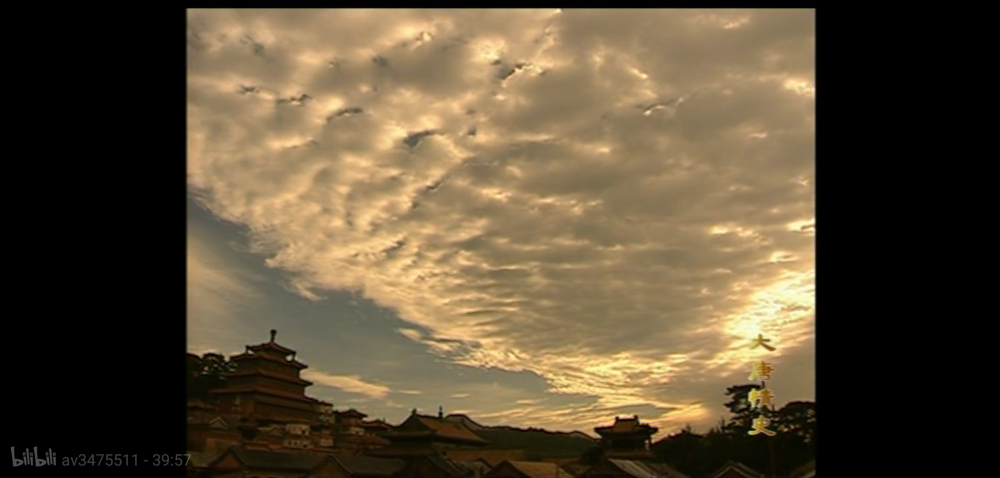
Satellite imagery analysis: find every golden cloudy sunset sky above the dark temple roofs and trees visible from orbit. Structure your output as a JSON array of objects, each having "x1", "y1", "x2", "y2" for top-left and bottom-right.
[{"x1": 186, "y1": 9, "x2": 816, "y2": 436}]
